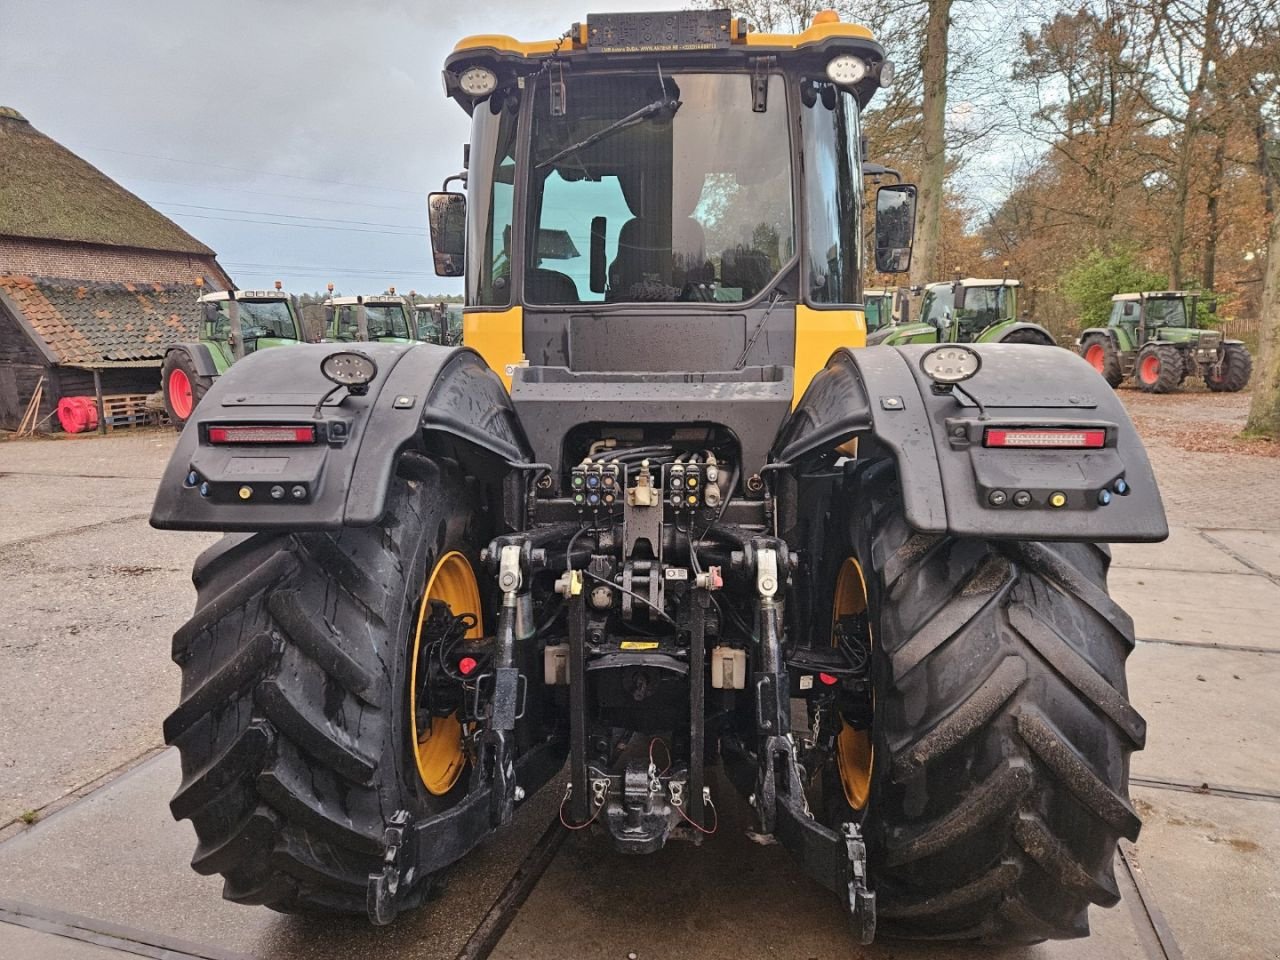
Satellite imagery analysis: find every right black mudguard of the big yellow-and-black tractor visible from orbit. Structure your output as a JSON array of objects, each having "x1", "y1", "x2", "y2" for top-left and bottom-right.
[{"x1": 773, "y1": 343, "x2": 1169, "y2": 541}]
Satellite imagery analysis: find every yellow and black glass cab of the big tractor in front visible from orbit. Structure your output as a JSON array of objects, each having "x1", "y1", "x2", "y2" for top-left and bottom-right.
[{"x1": 430, "y1": 10, "x2": 915, "y2": 399}]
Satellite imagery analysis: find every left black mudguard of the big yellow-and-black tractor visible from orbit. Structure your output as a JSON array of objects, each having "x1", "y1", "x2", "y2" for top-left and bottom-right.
[{"x1": 151, "y1": 343, "x2": 529, "y2": 531}]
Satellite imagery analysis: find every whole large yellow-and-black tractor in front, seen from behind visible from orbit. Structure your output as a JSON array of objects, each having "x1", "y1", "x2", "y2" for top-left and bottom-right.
[{"x1": 151, "y1": 10, "x2": 1167, "y2": 943}]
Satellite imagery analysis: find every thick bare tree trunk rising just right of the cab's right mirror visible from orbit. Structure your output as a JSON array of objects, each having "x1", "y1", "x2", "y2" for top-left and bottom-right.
[{"x1": 911, "y1": 0, "x2": 951, "y2": 284}]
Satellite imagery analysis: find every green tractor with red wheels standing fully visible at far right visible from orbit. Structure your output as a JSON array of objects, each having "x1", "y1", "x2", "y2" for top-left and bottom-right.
[{"x1": 1076, "y1": 291, "x2": 1253, "y2": 393}]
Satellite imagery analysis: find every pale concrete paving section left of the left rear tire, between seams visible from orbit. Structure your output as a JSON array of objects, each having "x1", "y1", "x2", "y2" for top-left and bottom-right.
[{"x1": 0, "y1": 519, "x2": 218, "y2": 826}]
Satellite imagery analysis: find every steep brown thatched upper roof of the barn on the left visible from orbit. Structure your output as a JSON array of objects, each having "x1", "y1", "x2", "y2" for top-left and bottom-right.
[{"x1": 0, "y1": 108, "x2": 214, "y2": 256}]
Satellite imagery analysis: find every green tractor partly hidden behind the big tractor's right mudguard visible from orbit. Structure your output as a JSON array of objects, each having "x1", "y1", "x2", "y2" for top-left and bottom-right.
[{"x1": 867, "y1": 276, "x2": 1056, "y2": 347}]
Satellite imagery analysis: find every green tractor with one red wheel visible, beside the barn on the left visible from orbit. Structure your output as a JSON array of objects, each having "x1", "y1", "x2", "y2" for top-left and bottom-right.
[{"x1": 160, "y1": 280, "x2": 305, "y2": 428}]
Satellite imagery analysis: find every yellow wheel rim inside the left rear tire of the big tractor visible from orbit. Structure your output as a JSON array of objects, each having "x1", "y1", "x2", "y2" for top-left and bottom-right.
[{"x1": 408, "y1": 550, "x2": 484, "y2": 796}]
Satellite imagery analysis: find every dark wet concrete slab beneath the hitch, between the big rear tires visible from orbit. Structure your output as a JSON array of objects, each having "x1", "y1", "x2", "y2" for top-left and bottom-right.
[{"x1": 492, "y1": 773, "x2": 1147, "y2": 960}]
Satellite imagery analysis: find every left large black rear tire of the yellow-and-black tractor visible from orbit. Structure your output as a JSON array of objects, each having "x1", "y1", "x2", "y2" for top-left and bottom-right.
[{"x1": 165, "y1": 454, "x2": 483, "y2": 914}]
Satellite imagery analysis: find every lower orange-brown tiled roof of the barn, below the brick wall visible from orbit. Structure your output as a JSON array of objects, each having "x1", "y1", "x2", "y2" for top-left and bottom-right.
[{"x1": 0, "y1": 275, "x2": 201, "y2": 365}]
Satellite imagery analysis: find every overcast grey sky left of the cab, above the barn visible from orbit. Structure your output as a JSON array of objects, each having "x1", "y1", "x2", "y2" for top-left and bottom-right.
[{"x1": 0, "y1": 0, "x2": 660, "y2": 293}]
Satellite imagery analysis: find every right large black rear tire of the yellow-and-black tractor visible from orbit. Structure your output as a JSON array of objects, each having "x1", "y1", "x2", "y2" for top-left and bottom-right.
[{"x1": 827, "y1": 463, "x2": 1146, "y2": 942}]
